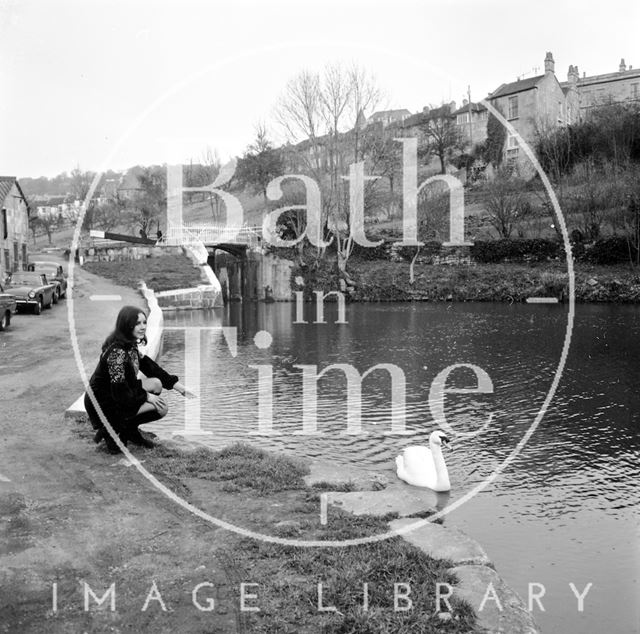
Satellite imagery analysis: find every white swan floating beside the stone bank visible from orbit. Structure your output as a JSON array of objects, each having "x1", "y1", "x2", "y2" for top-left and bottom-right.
[{"x1": 396, "y1": 430, "x2": 451, "y2": 492}]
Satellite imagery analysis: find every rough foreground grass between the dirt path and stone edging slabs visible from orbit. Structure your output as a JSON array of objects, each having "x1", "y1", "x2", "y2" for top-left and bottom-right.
[{"x1": 145, "y1": 443, "x2": 477, "y2": 634}]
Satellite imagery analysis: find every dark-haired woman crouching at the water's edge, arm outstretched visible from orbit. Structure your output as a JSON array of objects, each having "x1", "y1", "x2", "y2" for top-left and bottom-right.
[{"x1": 84, "y1": 306, "x2": 187, "y2": 453}]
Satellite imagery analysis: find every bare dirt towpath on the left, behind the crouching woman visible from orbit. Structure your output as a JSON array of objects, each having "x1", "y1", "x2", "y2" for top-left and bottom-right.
[{"x1": 0, "y1": 257, "x2": 243, "y2": 634}]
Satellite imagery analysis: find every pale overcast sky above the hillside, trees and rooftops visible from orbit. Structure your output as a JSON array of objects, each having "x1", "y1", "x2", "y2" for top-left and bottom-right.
[{"x1": 0, "y1": 0, "x2": 640, "y2": 177}]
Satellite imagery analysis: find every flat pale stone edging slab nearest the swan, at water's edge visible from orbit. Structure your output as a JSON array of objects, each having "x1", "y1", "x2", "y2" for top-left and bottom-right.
[{"x1": 327, "y1": 484, "x2": 435, "y2": 517}]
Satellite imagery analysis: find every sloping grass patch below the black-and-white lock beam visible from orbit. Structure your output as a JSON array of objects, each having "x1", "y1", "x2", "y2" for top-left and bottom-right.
[{"x1": 83, "y1": 255, "x2": 202, "y2": 291}]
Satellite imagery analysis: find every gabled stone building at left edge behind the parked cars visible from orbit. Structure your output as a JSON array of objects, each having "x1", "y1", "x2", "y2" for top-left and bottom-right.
[{"x1": 0, "y1": 176, "x2": 30, "y2": 280}]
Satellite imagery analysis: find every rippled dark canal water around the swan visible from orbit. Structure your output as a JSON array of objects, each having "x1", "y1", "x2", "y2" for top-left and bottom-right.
[{"x1": 155, "y1": 303, "x2": 640, "y2": 634}]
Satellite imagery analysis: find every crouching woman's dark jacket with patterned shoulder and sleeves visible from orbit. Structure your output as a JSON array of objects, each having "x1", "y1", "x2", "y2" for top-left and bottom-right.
[{"x1": 89, "y1": 343, "x2": 178, "y2": 423}]
